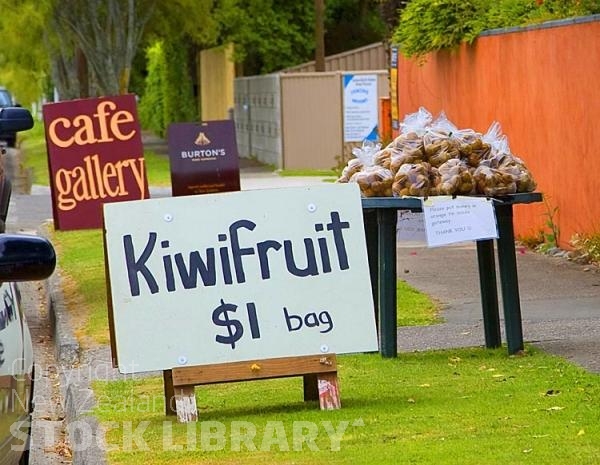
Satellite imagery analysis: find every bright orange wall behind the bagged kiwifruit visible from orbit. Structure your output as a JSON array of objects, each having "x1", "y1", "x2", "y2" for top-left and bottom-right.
[{"x1": 398, "y1": 19, "x2": 600, "y2": 247}]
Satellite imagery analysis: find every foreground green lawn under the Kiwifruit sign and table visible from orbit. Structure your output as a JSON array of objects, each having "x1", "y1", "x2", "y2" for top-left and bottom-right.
[{"x1": 93, "y1": 348, "x2": 600, "y2": 465}]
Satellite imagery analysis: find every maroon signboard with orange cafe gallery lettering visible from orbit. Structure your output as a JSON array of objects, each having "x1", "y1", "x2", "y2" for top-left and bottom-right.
[{"x1": 43, "y1": 95, "x2": 148, "y2": 230}]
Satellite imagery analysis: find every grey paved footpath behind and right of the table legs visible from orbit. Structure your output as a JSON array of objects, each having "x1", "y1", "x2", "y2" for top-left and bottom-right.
[{"x1": 398, "y1": 243, "x2": 600, "y2": 373}]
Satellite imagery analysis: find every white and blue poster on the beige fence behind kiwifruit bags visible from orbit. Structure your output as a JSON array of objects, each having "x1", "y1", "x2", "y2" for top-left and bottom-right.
[{"x1": 342, "y1": 74, "x2": 379, "y2": 142}]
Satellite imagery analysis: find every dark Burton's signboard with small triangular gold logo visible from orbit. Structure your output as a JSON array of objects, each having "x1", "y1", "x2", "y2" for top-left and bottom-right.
[{"x1": 168, "y1": 120, "x2": 240, "y2": 197}]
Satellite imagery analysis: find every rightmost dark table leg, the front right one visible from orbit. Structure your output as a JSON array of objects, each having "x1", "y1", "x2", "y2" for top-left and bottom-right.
[{"x1": 496, "y1": 204, "x2": 524, "y2": 355}]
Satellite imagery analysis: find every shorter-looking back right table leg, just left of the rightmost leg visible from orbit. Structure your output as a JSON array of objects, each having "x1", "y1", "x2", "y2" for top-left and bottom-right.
[{"x1": 477, "y1": 240, "x2": 502, "y2": 349}]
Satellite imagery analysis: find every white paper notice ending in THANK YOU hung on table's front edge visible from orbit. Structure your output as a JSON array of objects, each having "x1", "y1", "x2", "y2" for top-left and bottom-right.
[{"x1": 423, "y1": 196, "x2": 498, "y2": 247}]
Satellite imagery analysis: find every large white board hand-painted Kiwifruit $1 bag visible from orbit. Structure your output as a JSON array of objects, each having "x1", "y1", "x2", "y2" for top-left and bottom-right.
[{"x1": 104, "y1": 184, "x2": 377, "y2": 373}]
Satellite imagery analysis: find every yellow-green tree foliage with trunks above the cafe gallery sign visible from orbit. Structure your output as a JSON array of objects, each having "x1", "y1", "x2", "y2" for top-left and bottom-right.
[{"x1": 0, "y1": 0, "x2": 216, "y2": 103}]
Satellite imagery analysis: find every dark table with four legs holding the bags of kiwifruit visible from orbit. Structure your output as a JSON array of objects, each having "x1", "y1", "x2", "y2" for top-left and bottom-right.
[{"x1": 362, "y1": 192, "x2": 542, "y2": 357}]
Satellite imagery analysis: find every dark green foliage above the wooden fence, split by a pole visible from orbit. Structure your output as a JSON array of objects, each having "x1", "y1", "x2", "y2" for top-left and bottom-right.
[{"x1": 212, "y1": 0, "x2": 393, "y2": 75}]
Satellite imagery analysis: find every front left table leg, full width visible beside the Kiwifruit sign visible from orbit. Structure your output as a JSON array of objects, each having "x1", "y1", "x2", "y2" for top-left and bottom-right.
[{"x1": 377, "y1": 208, "x2": 398, "y2": 358}]
